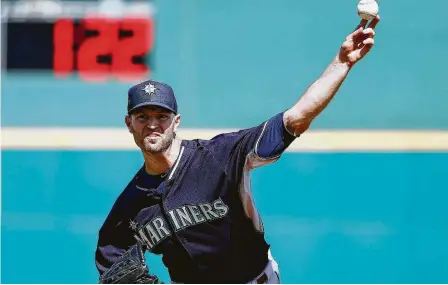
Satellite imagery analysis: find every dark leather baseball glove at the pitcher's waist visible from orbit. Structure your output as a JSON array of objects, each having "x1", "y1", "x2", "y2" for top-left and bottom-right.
[{"x1": 99, "y1": 241, "x2": 163, "y2": 284}]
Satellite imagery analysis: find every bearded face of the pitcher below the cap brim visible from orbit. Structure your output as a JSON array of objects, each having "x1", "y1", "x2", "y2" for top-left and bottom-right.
[{"x1": 126, "y1": 107, "x2": 180, "y2": 153}]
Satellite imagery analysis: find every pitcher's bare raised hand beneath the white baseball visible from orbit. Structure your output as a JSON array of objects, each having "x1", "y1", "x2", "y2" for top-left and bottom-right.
[{"x1": 338, "y1": 16, "x2": 380, "y2": 66}]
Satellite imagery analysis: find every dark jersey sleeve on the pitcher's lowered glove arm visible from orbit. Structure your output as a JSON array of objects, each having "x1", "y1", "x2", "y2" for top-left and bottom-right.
[{"x1": 95, "y1": 189, "x2": 137, "y2": 276}]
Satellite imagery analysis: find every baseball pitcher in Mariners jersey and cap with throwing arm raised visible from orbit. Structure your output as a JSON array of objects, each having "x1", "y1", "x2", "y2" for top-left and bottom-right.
[{"x1": 95, "y1": 17, "x2": 379, "y2": 284}]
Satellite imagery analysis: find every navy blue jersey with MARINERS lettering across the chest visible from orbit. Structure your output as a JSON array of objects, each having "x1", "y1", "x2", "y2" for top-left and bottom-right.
[{"x1": 96, "y1": 113, "x2": 295, "y2": 283}]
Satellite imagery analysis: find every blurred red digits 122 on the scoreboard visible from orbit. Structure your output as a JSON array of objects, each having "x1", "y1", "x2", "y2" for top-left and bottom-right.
[{"x1": 53, "y1": 18, "x2": 153, "y2": 81}]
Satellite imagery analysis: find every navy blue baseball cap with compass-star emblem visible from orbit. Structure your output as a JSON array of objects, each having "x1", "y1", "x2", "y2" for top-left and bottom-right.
[{"x1": 128, "y1": 80, "x2": 177, "y2": 114}]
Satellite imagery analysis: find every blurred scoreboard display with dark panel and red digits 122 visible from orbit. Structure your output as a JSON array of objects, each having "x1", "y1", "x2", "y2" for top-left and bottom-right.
[{"x1": 2, "y1": 0, "x2": 154, "y2": 81}]
